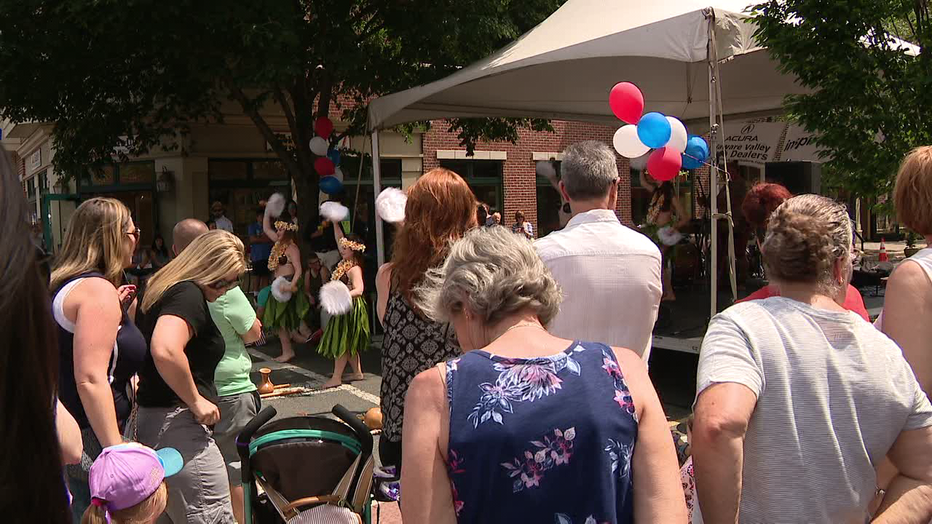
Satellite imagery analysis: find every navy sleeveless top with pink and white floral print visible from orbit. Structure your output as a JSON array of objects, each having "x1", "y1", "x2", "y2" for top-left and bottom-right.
[{"x1": 446, "y1": 342, "x2": 638, "y2": 524}]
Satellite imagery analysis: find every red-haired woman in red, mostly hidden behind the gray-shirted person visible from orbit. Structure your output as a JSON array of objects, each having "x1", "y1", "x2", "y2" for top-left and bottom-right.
[{"x1": 738, "y1": 182, "x2": 870, "y2": 322}]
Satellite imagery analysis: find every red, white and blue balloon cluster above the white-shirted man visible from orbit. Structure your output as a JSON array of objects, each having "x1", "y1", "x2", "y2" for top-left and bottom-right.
[{"x1": 608, "y1": 82, "x2": 709, "y2": 182}]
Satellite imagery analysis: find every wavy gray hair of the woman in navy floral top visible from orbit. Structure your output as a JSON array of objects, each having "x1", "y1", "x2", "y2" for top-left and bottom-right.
[{"x1": 414, "y1": 227, "x2": 563, "y2": 326}]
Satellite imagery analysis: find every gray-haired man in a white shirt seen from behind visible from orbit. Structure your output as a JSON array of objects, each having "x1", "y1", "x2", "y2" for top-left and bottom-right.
[{"x1": 534, "y1": 140, "x2": 662, "y2": 362}]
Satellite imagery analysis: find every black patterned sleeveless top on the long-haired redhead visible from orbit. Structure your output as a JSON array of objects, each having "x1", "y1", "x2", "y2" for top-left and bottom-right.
[{"x1": 379, "y1": 291, "x2": 463, "y2": 442}]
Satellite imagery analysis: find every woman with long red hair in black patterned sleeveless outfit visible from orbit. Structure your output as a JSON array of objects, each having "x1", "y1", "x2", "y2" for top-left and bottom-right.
[{"x1": 375, "y1": 168, "x2": 478, "y2": 468}]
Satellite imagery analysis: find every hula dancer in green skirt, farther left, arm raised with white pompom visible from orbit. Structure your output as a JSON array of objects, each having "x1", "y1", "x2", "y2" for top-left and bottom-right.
[{"x1": 262, "y1": 193, "x2": 311, "y2": 362}]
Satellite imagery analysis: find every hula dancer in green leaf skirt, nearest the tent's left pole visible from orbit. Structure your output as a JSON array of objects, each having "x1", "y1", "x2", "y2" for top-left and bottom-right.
[{"x1": 317, "y1": 225, "x2": 369, "y2": 389}]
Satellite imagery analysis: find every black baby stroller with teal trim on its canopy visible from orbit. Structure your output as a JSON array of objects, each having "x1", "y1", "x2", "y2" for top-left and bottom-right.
[{"x1": 236, "y1": 405, "x2": 374, "y2": 524}]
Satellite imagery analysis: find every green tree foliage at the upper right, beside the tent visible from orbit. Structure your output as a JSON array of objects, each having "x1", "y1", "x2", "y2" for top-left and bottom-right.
[{"x1": 753, "y1": 0, "x2": 932, "y2": 197}]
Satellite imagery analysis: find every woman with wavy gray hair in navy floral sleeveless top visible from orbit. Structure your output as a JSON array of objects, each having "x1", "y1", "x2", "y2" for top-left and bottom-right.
[{"x1": 401, "y1": 228, "x2": 686, "y2": 524}]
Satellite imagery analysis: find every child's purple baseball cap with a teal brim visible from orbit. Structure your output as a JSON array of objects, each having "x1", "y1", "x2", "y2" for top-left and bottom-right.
[{"x1": 88, "y1": 443, "x2": 184, "y2": 511}]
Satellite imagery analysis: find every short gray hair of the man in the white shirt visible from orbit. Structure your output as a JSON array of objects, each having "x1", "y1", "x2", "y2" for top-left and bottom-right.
[{"x1": 560, "y1": 140, "x2": 618, "y2": 200}]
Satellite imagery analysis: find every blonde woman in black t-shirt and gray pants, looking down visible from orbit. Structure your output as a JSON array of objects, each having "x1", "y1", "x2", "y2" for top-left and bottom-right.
[{"x1": 135, "y1": 230, "x2": 246, "y2": 523}]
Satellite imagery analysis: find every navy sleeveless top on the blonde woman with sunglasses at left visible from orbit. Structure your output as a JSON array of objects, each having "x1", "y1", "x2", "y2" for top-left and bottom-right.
[{"x1": 52, "y1": 273, "x2": 149, "y2": 429}]
